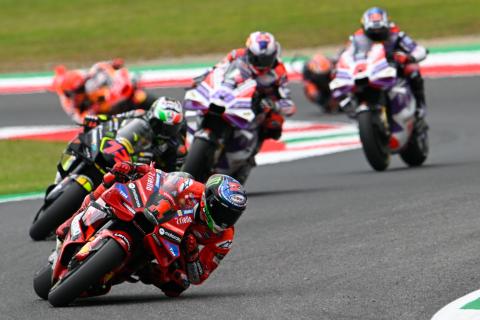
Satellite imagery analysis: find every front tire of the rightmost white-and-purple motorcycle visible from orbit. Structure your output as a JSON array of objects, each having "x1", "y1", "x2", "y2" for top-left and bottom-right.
[{"x1": 357, "y1": 112, "x2": 390, "y2": 171}]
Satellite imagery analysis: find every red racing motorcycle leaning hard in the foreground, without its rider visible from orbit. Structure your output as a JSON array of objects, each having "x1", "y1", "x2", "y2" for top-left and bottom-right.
[{"x1": 33, "y1": 165, "x2": 193, "y2": 307}]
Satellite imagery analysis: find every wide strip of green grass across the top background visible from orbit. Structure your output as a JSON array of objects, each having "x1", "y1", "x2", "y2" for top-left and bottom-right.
[{"x1": 0, "y1": 0, "x2": 480, "y2": 72}]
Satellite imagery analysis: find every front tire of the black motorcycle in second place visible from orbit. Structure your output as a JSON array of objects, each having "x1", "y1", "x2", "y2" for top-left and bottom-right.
[{"x1": 29, "y1": 181, "x2": 88, "y2": 241}]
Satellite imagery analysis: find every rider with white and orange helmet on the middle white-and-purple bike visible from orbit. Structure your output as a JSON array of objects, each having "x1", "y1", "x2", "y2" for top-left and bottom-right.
[{"x1": 194, "y1": 31, "x2": 297, "y2": 181}]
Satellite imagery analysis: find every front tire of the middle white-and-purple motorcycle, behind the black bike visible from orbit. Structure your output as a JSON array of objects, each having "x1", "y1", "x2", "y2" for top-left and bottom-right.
[{"x1": 182, "y1": 139, "x2": 215, "y2": 182}]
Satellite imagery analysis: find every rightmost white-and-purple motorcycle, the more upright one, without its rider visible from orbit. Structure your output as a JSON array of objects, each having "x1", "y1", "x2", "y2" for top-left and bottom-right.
[{"x1": 330, "y1": 43, "x2": 428, "y2": 171}]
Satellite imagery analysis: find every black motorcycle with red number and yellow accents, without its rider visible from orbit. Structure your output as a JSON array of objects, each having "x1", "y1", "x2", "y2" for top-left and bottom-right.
[{"x1": 29, "y1": 118, "x2": 150, "y2": 240}]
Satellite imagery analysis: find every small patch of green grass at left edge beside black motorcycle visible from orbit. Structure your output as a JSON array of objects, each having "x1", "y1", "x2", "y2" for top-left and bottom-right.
[{"x1": 0, "y1": 140, "x2": 66, "y2": 195}]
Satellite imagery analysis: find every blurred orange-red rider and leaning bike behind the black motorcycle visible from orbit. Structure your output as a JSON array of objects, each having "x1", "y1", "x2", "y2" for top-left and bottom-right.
[{"x1": 53, "y1": 58, "x2": 152, "y2": 122}]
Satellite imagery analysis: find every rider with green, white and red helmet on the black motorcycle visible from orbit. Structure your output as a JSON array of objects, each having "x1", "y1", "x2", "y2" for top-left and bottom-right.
[{"x1": 84, "y1": 97, "x2": 187, "y2": 172}]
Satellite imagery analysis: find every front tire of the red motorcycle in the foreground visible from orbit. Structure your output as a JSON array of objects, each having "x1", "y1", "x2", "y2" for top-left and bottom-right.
[{"x1": 48, "y1": 239, "x2": 125, "y2": 307}]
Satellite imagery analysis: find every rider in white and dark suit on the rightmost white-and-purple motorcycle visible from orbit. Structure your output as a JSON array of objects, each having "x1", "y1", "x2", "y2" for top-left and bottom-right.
[{"x1": 344, "y1": 7, "x2": 428, "y2": 124}]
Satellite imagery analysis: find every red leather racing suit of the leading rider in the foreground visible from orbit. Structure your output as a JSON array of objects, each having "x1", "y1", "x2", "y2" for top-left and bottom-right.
[{"x1": 56, "y1": 162, "x2": 235, "y2": 297}]
